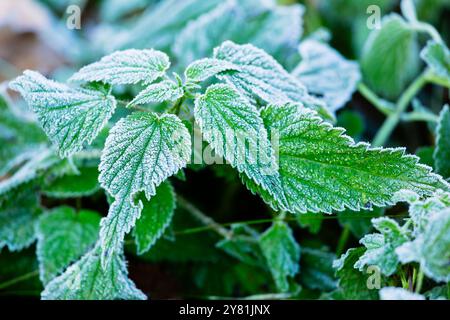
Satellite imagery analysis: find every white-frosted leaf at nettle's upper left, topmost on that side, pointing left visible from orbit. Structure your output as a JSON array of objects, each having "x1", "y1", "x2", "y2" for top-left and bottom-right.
[{"x1": 69, "y1": 49, "x2": 170, "y2": 85}]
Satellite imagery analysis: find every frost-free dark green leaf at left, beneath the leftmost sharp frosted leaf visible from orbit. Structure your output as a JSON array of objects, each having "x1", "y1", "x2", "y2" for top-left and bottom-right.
[{"x1": 42, "y1": 167, "x2": 100, "y2": 199}]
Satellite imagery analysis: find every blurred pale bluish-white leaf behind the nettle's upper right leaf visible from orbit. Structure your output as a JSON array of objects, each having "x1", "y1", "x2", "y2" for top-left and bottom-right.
[{"x1": 292, "y1": 39, "x2": 361, "y2": 112}]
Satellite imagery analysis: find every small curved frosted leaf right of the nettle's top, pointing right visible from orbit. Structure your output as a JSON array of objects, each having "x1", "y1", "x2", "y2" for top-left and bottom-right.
[{"x1": 184, "y1": 58, "x2": 239, "y2": 82}]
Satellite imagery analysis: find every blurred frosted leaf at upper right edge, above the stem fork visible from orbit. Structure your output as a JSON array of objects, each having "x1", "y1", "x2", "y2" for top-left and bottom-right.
[{"x1": 420, "y1": 41, "x2": 450, "y2": 87}]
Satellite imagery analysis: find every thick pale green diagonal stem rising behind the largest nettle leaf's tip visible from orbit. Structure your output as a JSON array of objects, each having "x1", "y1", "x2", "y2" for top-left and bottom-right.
[{"x1": 372, "y1": 70, "x2": 428, "y2": 147}]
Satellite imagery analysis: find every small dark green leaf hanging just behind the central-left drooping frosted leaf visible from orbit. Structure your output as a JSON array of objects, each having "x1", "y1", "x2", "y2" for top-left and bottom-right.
[{"x1": 133, "y1": 181, "x2": 175, "y2": 255}]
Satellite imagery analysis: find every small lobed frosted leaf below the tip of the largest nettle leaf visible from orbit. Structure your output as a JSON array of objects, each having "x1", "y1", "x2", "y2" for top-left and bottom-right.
[{"x1": 355, "y1": 217, "x2": 409, "y2": 276}]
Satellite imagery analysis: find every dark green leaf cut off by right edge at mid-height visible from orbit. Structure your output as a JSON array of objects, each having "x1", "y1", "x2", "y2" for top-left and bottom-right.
[{"x1": 433, "y1": 105, "x2": 450, "y2": 178}]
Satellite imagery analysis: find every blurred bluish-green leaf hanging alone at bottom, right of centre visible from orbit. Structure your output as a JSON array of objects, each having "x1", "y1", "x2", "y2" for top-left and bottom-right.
[{"x1": 259, "y1": 222, "x2": 300, "y2": 292}]
